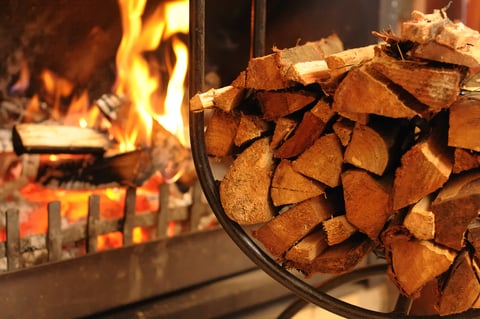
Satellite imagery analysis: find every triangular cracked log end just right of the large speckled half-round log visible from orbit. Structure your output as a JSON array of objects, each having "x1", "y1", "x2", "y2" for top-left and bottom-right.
[{"x1": 270, "y1": 160, "x2": 325, "y2": 206}]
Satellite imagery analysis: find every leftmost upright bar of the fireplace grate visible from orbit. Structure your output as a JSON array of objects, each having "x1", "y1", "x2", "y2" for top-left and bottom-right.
[{"x1": 6, "y1": 209, "x2": 20, "y2": 271}]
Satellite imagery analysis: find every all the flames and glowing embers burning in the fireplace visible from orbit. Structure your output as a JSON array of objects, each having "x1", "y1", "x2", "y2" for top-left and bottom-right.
[{"x1": 0, "y1": 0, "x2": 189, "y2": 250}]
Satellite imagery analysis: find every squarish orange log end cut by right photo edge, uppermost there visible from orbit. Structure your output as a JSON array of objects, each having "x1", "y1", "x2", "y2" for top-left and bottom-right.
[{"x1": 448, "y1": 98, "x2": 480, "y2": 152}]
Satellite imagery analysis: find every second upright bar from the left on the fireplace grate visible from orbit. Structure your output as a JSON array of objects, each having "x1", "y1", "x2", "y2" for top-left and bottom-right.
[{"x1": 47, "y1": 201, "x2": 62, "y2": 261}]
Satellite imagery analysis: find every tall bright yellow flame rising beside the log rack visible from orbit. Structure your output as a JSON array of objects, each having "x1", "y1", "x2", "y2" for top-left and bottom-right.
[{"x1": 114, "y1": 0, "x2": 188, "y2": 151}]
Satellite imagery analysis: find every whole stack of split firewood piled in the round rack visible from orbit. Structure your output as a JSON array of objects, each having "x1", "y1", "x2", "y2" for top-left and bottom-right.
[{"x1": 191, "y1": 9, "x2": 480, "y2": 315}]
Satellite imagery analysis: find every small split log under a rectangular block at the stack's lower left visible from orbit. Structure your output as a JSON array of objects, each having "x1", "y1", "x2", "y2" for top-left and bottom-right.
[{"x1": 285, "y1": 229, "x2": 328, "y2": 265}]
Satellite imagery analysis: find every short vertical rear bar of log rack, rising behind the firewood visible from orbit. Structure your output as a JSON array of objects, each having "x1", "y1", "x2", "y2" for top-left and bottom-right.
[{"x1": 250, "y1": 0, "x2": 267, "y2": 58}]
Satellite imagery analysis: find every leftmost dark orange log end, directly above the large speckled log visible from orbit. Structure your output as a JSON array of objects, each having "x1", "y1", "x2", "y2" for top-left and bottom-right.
[{"x1": 205, "y1": 109, "x2": 239, "y2": 157}]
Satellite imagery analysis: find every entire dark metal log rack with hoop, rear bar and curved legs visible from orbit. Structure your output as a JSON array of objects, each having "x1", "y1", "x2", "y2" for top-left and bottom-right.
[{"x1": 189, "y1": 0, "x2": 480, "y2": 319}]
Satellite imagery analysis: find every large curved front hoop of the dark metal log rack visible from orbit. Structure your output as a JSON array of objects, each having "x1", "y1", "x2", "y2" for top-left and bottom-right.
[{"x1": 189, "y1": 0, "x2": 480, "y2": 319}]
